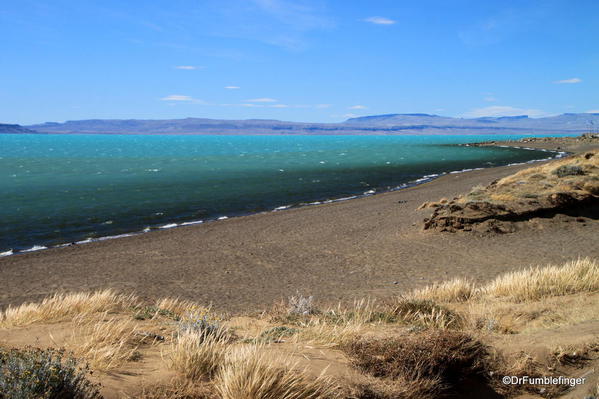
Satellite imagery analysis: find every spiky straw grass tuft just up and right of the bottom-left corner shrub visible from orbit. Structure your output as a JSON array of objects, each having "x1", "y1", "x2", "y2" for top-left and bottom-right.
[{"x1": 69, "y1": 315, "x2": 143, "y2": 371}]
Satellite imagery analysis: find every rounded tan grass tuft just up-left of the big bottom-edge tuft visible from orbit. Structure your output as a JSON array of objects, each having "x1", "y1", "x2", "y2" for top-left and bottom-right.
[{"x1": 166, "y1": 331, "x2": 230, "y2": 380}]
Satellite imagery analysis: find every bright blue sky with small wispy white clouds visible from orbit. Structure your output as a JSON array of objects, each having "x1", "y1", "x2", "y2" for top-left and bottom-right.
[{"x1": 0, "y1": 0, "x2": 599, "y2": 124}]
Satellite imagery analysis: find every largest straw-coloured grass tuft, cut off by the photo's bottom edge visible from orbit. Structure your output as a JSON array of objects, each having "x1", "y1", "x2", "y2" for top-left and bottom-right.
[{"x1": 214, "y1": 346, "x2": 338, "y2": 399}]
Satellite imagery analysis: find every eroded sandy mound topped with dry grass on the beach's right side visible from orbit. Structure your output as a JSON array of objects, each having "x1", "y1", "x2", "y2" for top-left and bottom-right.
[{"x1": 420, "y1": 150, "x2": 599, "y2": 233}]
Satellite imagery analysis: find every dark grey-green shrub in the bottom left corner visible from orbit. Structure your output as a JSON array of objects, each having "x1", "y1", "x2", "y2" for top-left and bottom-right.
[{"x1": 0, "y1": 348, "x2": 102, "y2": 399}]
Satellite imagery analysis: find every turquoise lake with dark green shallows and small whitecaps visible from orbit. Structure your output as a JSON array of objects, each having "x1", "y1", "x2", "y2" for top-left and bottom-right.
[{"x1": 0, "y1": 134, "x2": 564, "y2": 254}]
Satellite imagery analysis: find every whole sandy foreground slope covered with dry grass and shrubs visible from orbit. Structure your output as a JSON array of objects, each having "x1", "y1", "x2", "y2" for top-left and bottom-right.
[{"x1": 0, "y1": 259, "x2": 599, "y2": 399}]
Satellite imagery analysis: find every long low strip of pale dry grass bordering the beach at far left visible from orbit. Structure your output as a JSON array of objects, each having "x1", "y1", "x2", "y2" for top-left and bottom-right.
[{"x1": 0, "y1": 290, "x2": 137, "y2": 327}]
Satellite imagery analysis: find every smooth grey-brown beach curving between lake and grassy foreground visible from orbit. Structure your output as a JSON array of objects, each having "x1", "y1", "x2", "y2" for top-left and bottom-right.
[{"x1": 0, "y1": 142, "x2": 599, "y2": 313}]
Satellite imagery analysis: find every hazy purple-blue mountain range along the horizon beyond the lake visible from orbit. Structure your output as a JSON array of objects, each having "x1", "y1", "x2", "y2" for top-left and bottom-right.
[{"x1": 0, "y1": 113, "x2": 599, "y2": 135}]
